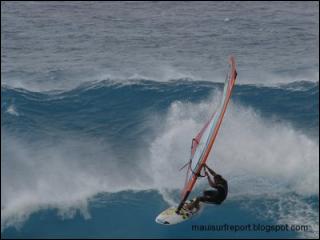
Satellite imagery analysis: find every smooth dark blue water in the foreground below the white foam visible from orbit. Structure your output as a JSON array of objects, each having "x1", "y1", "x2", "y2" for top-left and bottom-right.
[{"x1": 6, "y1": 192, "x2": 308, "y2": 238}]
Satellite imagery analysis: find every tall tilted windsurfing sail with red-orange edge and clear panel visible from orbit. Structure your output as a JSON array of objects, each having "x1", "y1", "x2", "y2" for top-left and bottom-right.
[{"x1": 176, "y1": 56, "x2": 237, "y2": 213}]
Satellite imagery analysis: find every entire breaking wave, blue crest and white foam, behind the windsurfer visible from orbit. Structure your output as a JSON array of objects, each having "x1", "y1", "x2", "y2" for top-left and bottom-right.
[{"x1": 1, "y1": 79, "x2": 319, "y2": 236}]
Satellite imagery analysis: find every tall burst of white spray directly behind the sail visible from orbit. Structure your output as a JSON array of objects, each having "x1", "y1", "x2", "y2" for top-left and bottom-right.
[{"x1": 151, "y1": 93, "x2": 319, "y2": 194}]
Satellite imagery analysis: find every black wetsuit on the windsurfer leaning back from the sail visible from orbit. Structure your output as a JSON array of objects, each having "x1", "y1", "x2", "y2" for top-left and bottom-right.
[{"x1": 200, "y1": 178, "x2": 228, "y2": 204}]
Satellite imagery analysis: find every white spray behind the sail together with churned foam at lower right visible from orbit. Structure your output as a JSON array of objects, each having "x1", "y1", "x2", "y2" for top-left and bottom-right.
[{"x1": 151, "y1": 93, "x2": 319, "y2": 237}]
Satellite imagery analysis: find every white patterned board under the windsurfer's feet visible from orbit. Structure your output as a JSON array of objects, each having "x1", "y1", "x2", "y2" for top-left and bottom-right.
[{"x1": 156, "y1": 201, "x2": 202, "y2": 225}]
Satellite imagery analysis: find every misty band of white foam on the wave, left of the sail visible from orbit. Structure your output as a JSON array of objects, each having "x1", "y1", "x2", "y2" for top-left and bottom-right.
[{"x1": 1, "y1": 134, "x2": 150, "y2": 229}]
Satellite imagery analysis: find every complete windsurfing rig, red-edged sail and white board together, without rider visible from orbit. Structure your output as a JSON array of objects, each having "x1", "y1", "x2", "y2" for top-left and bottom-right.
[{"x1": 156, "y1": 56, "x2": 237, "y2": 224}]
